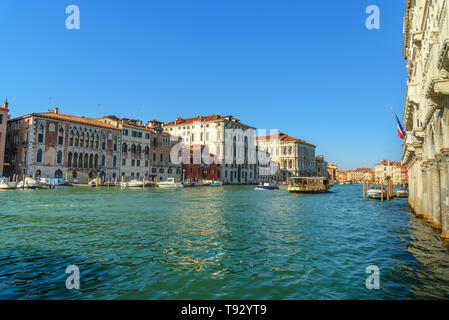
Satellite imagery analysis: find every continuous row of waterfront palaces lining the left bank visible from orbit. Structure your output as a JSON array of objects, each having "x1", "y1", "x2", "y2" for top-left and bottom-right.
[{"x1": 0, "y1": 101, "x2": 336, "y2": 184}]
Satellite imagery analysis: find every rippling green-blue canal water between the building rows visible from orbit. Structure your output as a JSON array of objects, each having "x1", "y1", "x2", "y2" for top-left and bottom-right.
[{"x1": 0, "y1": 186, "x2": 449, "y2": 299}]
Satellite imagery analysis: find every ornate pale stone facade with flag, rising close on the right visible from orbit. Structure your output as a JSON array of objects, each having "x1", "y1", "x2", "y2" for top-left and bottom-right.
[{"x1": 402, "y1": 0, "x2": 449, "y2": 238}]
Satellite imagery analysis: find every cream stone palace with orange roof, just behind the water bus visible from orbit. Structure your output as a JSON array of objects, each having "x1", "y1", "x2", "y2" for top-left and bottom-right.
[{"x1": 256, "y1": 132, "x2": 316, "y2": 181}]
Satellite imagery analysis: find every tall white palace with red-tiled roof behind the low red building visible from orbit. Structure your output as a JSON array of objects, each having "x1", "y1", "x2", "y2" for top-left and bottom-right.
[{"x1": 162, "y1": 114, "x2": 256, "y2": 184}]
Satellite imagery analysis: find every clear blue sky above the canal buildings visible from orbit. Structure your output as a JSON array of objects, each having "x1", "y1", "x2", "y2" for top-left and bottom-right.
[{"x1": 0, "y1": 0, "x2": 407, "y2": 169}]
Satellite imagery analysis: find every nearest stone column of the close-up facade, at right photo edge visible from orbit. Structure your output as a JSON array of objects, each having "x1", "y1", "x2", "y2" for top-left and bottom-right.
[{"x1": 438, "y1": 152, "x2": 449, "y2": 239}]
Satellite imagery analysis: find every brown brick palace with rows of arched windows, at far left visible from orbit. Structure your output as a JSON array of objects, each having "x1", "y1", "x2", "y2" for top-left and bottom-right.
[{"x1": 6, "y1": 108, "x2": 120, "y2": 183}]
